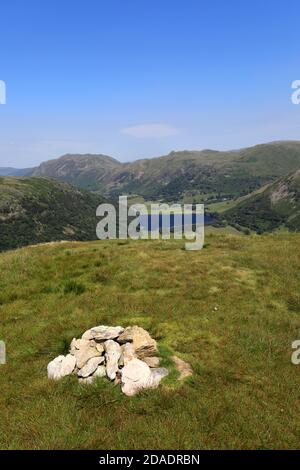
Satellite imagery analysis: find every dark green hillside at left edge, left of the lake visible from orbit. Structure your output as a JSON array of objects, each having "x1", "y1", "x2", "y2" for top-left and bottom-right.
[{"x1": 0, "y1": 177, "x2": 103, "y2": 250}]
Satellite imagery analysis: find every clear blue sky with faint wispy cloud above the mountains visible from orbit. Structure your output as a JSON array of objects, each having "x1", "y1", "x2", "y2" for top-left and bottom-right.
[{"x1": 0, "y1": 0, "x2": 300, "y2": 167}]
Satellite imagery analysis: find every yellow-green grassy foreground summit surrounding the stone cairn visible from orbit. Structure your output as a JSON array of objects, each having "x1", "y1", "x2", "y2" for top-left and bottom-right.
[{"x1": 0, "y1": 234, "x2": 300, "y2": 449}]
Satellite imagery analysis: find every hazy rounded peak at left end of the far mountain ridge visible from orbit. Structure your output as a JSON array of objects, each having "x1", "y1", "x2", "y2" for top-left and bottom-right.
[{"x1": 31, "y1": 154, "x2": 122, "y2": 191}]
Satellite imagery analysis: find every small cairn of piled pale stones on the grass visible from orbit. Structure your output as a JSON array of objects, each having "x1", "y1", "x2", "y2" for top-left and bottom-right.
[{"x1": 47, "y1": 326, "x2": 168, "y2": 396}]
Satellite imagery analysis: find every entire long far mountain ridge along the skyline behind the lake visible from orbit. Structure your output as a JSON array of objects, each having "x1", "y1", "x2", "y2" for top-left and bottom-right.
[{"x1": 28, "y1": 141, "x2": 300, "y2": 200}]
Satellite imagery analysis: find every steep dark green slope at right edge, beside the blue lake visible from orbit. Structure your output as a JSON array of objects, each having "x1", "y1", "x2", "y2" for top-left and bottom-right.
[{"x1": 222, "y1": 169, "x2": 300, "y2": 233}]
